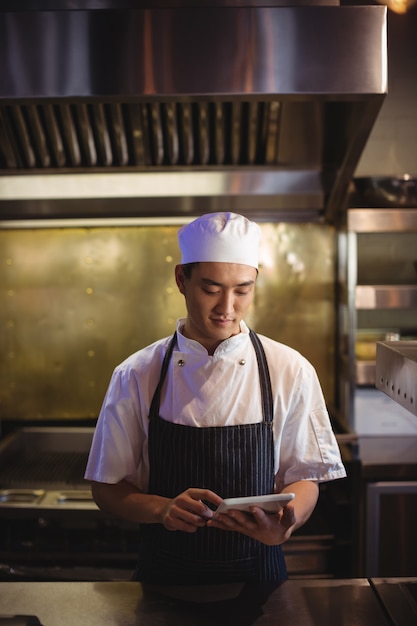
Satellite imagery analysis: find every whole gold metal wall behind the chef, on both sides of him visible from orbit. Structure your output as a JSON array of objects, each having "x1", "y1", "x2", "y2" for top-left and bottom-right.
[{"x1": 0, "y1": 224, "x2": 334, "y2": 420}]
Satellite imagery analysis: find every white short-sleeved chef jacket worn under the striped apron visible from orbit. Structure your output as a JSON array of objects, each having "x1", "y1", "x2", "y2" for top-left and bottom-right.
[{"x1": 85, "y1": 320, "x2": 346, "y2": 492}]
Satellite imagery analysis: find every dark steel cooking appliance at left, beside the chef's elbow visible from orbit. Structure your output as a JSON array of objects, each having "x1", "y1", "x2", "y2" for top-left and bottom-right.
[{"x1": 0, "y1": 426, "x2": 137, "y2": 580}]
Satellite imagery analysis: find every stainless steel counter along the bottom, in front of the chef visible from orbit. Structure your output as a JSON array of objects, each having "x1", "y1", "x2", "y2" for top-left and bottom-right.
[{"x1": 0, "y1": 579, "x2": 417, "y2": 626}]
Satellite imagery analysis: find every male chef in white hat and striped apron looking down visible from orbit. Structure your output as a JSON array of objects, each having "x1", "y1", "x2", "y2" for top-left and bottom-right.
[{"x1": 85, "y1": 212, "x2": 346, "y2": 585}]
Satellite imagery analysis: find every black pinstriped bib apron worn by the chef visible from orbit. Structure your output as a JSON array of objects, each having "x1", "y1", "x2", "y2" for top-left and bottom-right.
[{"x1": 135, "y1": 331, "x2": 287, "y2": 585}]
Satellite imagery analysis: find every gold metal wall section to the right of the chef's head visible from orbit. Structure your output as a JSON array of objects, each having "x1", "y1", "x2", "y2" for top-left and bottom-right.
[{"x1": 252, "y1": 223, "x2": 336, "y2": 405}]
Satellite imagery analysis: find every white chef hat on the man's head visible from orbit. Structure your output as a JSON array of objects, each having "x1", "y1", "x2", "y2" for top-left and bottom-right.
[{"x1": 178, "y1": 212, "x2": 261, "y2": 268}]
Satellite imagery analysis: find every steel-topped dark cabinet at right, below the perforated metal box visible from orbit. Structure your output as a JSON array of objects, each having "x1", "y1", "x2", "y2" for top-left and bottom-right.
[{"x1": 355, "y1": 434, "x2": 417, "y2": 576}]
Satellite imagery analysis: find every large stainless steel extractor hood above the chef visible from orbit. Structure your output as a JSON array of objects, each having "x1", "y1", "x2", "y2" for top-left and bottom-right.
[{"x1": 0, "y1": 0, "x2": 387, "y2": 221}]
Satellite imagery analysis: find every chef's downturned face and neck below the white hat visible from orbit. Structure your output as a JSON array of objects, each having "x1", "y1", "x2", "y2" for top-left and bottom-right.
[{"x1": 175, "y1": 263, "x2": 257, "y2": 354}]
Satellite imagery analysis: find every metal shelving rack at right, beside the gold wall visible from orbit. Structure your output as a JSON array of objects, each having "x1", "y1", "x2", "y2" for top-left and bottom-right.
[{"x1": 337, "y1": 206, "x2": 417, "y2": 435}]
